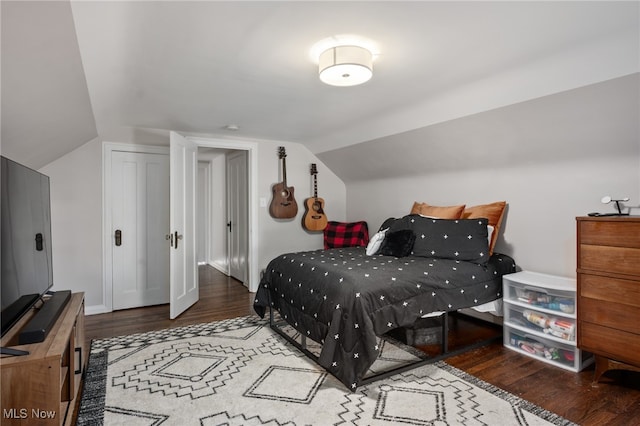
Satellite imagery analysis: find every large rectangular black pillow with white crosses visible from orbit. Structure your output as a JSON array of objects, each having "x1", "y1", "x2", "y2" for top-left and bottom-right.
[{"x1": 412, "y1": 216, "x2": 489, "y2": 264}]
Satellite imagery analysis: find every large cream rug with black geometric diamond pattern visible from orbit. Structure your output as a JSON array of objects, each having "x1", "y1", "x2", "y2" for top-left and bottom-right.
[{"x1": 77, "y1": 316, "x2": 573, "y2": 426}]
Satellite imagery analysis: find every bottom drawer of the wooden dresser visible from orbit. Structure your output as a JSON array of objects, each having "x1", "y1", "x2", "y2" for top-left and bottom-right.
[{"x1": 578, "y1": 322, "x2": 640, "y2": 367}]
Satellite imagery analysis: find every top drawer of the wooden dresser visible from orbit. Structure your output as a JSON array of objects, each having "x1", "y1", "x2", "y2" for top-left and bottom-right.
[{"x1": 578, "y1": 220, "x2": 640, "y2": 248}]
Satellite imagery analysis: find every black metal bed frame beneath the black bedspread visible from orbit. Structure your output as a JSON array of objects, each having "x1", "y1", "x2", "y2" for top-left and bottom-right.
[{"x1": 269, "y1": 306, "x2": 502, "y2": 392}]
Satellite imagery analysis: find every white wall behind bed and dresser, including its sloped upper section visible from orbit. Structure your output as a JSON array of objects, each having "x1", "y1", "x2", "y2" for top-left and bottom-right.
[{"x1": 338, "y1": 74, "x2": 640, "y2": 277}]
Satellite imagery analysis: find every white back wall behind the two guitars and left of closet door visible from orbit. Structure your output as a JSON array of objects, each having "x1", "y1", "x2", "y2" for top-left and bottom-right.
[{"x1": 40, "y1": 132, "x2": 346, "y2": 314}]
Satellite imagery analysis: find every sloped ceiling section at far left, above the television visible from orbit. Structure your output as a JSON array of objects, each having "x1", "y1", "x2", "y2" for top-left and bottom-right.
[{"x1": 0, "y1": 1, "x2": 98, "y2": 169}]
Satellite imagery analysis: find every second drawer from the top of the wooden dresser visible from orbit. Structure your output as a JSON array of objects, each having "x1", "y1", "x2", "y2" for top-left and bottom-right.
[{"x1": 578, "y1": 243, "x2": 640, "y2": 275}]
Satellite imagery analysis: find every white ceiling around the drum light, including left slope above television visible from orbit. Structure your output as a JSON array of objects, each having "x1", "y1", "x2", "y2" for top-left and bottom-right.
[{"x1": 2, "y1": 1, "x2": 640, "y2": 167}]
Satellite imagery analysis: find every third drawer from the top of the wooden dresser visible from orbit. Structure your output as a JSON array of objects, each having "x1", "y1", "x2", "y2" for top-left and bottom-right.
[{"x1": 578, "y1": 274, "x2": 640, "y2": 308}]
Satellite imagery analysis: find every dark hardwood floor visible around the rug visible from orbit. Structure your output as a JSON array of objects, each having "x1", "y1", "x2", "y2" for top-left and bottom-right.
[{"x1": 85, "y1": 266, "x2": 640, "y2": 426}]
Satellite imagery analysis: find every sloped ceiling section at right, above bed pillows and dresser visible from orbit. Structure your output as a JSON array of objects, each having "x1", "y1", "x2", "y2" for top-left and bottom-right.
[{"x1": 318, "y1": 73, "x2": 640, "y2": 182}]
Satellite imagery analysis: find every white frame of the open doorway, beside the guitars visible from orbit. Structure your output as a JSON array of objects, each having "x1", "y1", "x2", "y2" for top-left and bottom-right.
[{"x1": 187, "y1": 136, "x2": 260, "y2": 293}]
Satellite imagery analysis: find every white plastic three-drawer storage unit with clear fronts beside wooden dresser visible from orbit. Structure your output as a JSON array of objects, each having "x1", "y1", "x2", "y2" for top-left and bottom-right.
[{"x1": 502, "y1": 271, "x2": 593, "y2": 371}]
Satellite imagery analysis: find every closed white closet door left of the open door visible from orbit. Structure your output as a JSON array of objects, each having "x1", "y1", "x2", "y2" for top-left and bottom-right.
[{"x1": 111, "y1": 151, "x2": 169, "y2": 309}]
